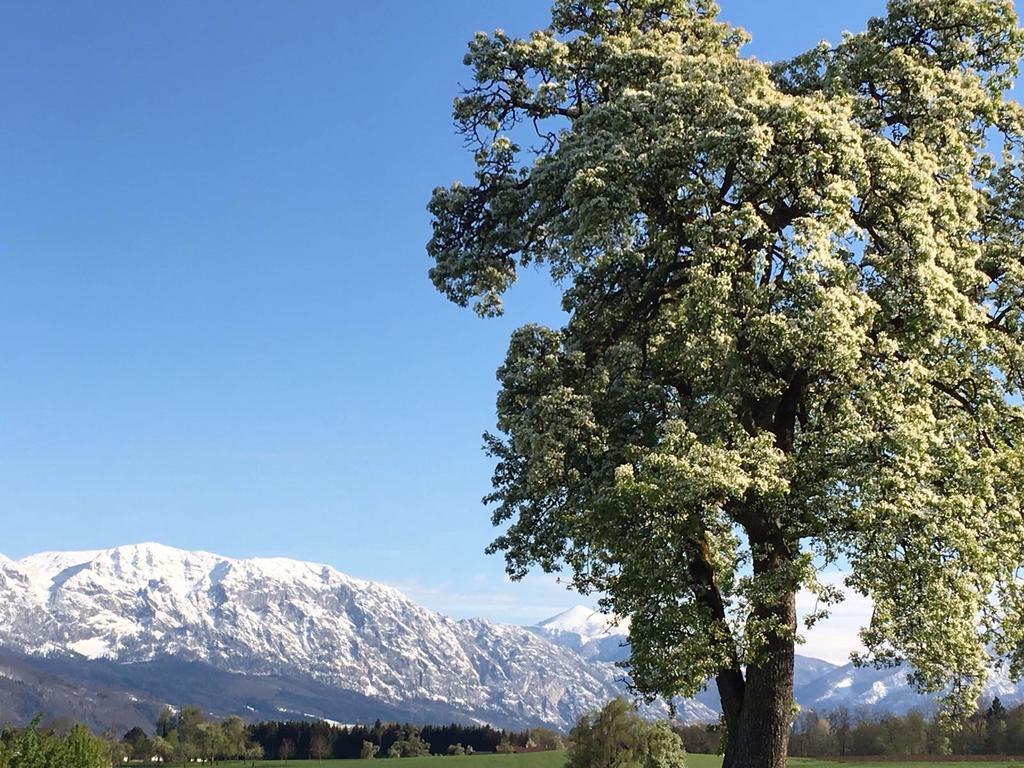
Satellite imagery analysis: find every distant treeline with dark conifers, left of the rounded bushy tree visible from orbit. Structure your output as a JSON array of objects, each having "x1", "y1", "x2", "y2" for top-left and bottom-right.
[{"x1": 124, "y1": 707, "x2": 562, "y2": 768}]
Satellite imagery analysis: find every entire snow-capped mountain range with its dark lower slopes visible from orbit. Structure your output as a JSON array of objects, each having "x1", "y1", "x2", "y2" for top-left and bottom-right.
[{"x1": 0, "y1": 544, "x2": 1024, "y2": 729}]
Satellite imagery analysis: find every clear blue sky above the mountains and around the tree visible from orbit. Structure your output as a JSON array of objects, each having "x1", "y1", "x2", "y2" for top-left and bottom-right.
[{"x1": 0, "y1": 0, "x2": 897, "y2": 656}]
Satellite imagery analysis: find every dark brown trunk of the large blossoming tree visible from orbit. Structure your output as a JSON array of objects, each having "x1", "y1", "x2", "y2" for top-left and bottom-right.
[{"x1": 718, "y1": 592, "x2": 797, "y2": 768}]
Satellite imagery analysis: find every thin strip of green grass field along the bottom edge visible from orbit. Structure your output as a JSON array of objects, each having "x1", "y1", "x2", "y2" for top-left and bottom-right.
[{"x1": 218, "y1": 752, "x2": 1024, "y2": 768}]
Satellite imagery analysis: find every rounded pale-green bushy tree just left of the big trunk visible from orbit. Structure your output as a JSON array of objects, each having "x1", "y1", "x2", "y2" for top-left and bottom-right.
[{"x1": 566, "y1": 698, "x2": 685, "y2": 768}]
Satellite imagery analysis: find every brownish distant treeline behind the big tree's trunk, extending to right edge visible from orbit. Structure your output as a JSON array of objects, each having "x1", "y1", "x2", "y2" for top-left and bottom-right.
[{"x1": 676, "y1": 697, "x2": 1024, "y2": 758}]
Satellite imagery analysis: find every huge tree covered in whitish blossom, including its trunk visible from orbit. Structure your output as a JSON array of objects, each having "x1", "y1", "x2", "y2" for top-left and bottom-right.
[{"x1": 428, "y1": 0, "x2": 1024, "y2": 768}]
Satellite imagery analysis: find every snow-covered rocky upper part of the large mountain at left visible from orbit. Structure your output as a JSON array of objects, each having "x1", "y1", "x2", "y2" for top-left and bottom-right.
[{"x1": 0, "y1": 544, "x2": 624, "y2": 727}]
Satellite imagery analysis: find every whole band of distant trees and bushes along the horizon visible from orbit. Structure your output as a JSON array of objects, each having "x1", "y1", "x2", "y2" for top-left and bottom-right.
[{"x1": 29, "y1": 697, "x2": 1024, "y2": 768}]
